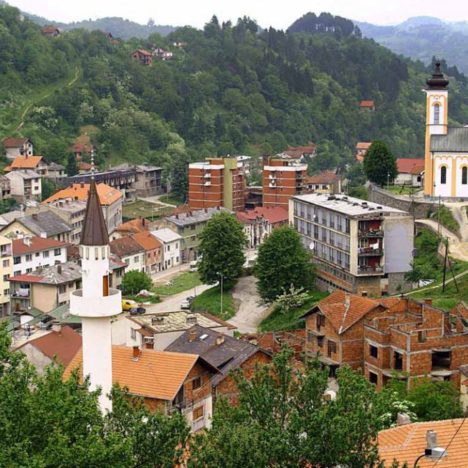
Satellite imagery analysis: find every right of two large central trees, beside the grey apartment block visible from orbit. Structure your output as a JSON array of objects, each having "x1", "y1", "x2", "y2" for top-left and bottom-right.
[{"x1": 255, "y1": 226, "x2": 314, "y2": 302}]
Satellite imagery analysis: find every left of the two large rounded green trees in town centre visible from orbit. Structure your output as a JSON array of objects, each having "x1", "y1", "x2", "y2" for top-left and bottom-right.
[{"x1": 198, "y1": 211, "x2": 247, "y2": 284}]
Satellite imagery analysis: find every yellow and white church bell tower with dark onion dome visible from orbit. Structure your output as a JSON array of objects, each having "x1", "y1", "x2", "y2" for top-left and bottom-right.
[{"x1": 424, "y1": 62, "x2": 449, "y2": 196}]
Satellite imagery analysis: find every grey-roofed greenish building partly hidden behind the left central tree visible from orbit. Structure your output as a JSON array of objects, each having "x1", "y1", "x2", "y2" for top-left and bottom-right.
[{"x1": 165, "y1": 207, "x2": 230, "y2": 263}]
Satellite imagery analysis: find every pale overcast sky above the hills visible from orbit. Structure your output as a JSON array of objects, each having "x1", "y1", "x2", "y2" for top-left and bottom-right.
[{"x1": 7, "y1": 0, "x2": 468, "y2": 29}]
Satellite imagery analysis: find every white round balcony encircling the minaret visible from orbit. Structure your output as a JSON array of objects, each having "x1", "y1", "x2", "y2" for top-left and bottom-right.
[{"x1": 70, "y1": 288, "x2": 122, "y2": 318}]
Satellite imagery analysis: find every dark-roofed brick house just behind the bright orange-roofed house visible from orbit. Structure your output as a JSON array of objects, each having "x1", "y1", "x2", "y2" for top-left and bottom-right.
[{"x1": 166, "y1": 325, "x2": 271, "y2": 403}]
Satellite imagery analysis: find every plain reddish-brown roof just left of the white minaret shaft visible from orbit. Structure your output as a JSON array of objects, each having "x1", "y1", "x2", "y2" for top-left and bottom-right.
[{"x1": 18, "y1": 326, "x2": 82, "y2": 366}]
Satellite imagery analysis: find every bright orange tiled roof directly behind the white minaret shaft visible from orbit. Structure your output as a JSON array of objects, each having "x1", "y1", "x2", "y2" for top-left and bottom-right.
[{"x1": 63, "y1": 346, "x2": 200, "y2": 401}]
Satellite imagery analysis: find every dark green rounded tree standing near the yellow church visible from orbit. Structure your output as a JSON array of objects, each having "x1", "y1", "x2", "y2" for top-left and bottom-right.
[{"x1": 364, "y1": 141, "x2": 398, "y2": 186}]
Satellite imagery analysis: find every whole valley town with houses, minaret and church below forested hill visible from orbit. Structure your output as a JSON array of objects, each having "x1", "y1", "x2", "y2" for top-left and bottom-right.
[{"x1": 0, "y1": 2, "x2": 468, "y2": 467}]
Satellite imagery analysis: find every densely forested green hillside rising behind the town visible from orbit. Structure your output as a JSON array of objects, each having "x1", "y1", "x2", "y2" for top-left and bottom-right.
[{"x1": 0, "y1": 6, "x2": 468, "y2": 196}]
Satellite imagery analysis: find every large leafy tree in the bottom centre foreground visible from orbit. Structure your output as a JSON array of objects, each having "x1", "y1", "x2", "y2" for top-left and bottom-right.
[{"x1": 190, "y1": 349, "x2": 394, "y2": 468}]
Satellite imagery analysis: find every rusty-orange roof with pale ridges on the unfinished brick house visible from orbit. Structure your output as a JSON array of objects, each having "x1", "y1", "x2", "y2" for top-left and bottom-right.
[{"x1": 317, "y1": 289, "x2": 381, "y2": 334}]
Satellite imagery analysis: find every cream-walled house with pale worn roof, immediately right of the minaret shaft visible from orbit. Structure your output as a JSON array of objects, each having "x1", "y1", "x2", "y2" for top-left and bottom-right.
[{"x1": 112, "y1": 310, "x2": 236, "y2": 351}]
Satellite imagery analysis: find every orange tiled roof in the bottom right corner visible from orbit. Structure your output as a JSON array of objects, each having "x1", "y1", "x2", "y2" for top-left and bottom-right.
[{"x1": 378, "y1": 419, "x2": 468, "y2": 468}]
